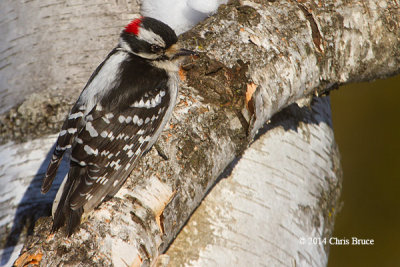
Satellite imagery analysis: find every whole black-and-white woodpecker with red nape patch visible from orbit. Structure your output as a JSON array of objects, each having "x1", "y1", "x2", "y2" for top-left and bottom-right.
[{"x1": 42, "y1": 17, "x2": 193, "y2": 235}]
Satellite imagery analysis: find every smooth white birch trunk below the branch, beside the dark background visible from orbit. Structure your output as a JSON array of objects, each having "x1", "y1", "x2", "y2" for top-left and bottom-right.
[{"x1": 167, "y1": 97, "x2": 342, "y2": 266}]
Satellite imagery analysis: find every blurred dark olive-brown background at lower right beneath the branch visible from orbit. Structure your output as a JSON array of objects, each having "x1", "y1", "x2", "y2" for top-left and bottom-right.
[{"x1": 328, "y1": 75, "x2": 400, "y2": 267}]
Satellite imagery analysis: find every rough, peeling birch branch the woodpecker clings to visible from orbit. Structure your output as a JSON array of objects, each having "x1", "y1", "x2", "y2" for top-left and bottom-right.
[{"x1": 0, "y1": 1, "x2": 400, "y2": 266}]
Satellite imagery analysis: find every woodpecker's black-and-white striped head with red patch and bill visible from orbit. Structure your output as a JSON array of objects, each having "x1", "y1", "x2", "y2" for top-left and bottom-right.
[{"x1": 119, "y1": 17, "x2": 196, "y2": 61}]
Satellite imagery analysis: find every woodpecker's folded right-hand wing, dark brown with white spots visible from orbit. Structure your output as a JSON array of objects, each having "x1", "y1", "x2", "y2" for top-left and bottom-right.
[{"x1": 69, "y1": 87, "x2": 170, "y2": 211}]
